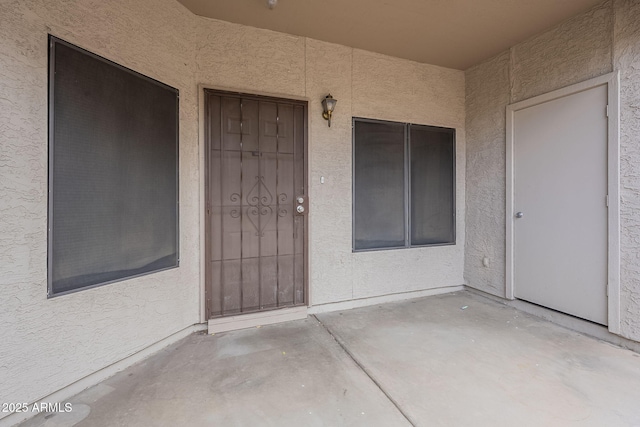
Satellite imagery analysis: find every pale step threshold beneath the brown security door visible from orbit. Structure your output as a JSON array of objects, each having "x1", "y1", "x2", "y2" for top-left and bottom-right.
[{"x1": 208, "y1": 306, "x2": 307, "y2": 334}]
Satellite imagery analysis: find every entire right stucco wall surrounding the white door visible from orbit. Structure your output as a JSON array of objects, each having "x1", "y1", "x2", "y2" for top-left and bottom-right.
[{"x1": 464, "y1": 0, "x2": 640, "y2": 341}]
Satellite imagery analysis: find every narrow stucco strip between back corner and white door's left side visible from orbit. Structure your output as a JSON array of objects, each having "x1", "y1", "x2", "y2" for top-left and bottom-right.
[{"x1": 464, "y1": 51, "x2": 510, "y2": 297}]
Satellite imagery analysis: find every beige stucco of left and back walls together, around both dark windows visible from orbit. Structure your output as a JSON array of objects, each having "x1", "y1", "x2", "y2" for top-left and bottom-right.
[{"x1": 0, "y1": 0, "x2": 465, "y2": 418}]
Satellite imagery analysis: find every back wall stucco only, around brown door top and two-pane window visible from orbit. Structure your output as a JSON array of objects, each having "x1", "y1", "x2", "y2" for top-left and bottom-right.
[{"x1": 196, "y1": 18, "x2": 465, "y2": 305}]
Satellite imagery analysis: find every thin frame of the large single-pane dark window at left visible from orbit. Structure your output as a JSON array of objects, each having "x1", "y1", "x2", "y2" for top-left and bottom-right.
[{"x1": 47, "y1": 34, "x2": 180, "y2": 299}]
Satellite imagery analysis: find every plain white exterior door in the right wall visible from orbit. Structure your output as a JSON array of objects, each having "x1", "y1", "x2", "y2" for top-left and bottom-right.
[{"x1": 512, "y1": 84, "x2": 608, "y2": 325}]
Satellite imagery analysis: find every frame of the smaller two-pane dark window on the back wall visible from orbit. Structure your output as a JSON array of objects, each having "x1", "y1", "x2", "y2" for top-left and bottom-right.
[{"x1": 351, "y1": 117, "x2": 457, "y2": 253}]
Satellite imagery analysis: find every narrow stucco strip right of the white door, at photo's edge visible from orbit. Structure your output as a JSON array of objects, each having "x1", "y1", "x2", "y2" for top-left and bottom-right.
[{"x1": 614, "y1": 0, "x2": 640, "y2": 341}]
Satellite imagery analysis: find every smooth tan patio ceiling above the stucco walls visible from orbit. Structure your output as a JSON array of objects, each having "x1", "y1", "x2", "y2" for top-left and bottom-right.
[{"x1": 178, "y1": 0, "x2": 602, "y2": 70}]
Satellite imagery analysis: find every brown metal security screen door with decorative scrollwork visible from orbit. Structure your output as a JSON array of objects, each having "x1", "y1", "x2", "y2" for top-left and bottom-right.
[{"x1": 205, "y1": 91, "x2": 308, "y2": 318}]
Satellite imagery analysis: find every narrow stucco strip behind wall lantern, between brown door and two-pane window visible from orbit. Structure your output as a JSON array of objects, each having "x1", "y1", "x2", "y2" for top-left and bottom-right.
[{"x1": 306, "y1": 39, "x2": 354, "y2": 304}]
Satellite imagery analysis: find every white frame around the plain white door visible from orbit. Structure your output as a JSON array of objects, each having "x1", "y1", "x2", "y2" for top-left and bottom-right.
[{"x1": 505, "y1": 72, "x2": 620, "y2": 334}]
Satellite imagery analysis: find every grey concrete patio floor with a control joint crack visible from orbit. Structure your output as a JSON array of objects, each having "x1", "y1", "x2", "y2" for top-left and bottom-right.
[{"x1": 22, "y1": 292, "x2": 640, "y2": 427}]
